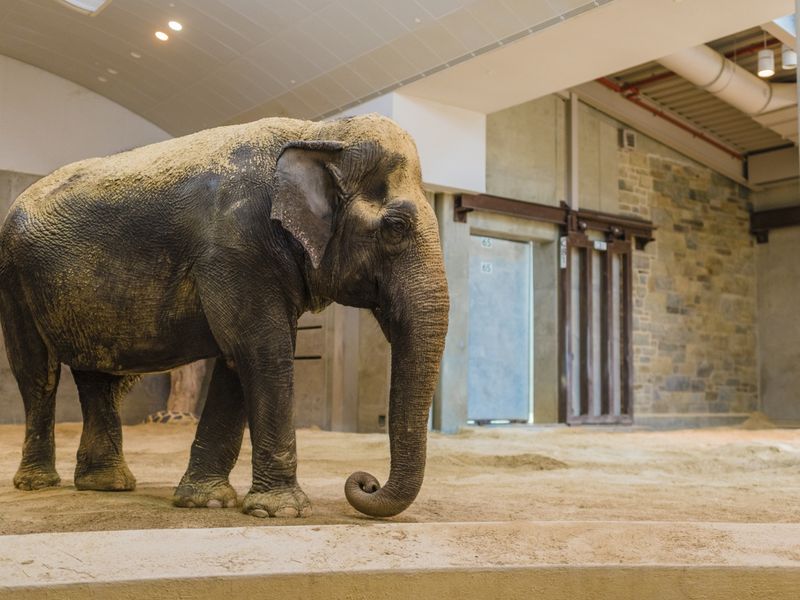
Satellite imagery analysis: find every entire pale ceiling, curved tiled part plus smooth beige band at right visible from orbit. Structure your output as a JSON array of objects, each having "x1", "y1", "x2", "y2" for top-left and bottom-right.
[{"x1": 0, "y1": 0, "x2": 794, "y2": 135}]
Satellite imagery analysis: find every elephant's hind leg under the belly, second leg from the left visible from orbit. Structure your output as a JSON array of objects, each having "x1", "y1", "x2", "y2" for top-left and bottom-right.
[{"x1": 72, "y1": 369, "x2": 138, "y2": 491}]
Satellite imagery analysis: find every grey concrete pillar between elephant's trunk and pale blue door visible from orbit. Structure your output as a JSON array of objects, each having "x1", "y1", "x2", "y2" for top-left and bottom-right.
[{"x1": 433, "y1": 194, "x2": 469, "y2": 433}]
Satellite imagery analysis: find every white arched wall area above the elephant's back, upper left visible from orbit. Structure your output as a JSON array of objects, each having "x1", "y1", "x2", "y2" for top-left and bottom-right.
[{"x1": 0, "y1": 56, "x2": 171, "y2": 175}]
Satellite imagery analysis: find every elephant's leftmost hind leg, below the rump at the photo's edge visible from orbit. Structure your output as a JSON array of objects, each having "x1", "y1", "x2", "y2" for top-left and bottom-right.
[{"x1": 0, "y1": 289, "x2": 61, "y2": 490}]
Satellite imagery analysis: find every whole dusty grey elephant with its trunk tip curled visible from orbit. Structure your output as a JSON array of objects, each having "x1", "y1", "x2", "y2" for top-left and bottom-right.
[{"x1": 0, "y1": 114, "x2": 449, "y2": 517}]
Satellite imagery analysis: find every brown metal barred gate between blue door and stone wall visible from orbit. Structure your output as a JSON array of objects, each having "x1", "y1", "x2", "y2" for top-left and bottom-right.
[{"x1": 559, "y1": 231, "x2": 633, "y2": 425}]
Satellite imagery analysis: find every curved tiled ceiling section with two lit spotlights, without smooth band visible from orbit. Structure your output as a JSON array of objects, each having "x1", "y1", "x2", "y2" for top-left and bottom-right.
[{"x1": 0, "y1": 0, "x2": 612, "y2": 134}]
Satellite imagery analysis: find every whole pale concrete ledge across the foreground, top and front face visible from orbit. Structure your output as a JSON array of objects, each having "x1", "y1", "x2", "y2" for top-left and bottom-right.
[{"x1": 0, "y1": 521, "x2": 800, "y2": 600}]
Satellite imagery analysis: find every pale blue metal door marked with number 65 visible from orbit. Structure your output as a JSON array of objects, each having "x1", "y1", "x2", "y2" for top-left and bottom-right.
[{"x1": 467, "y1": 236, "x2": 533, "y2": 423}]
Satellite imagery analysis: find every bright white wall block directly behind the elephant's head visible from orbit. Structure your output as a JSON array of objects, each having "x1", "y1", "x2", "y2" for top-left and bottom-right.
[{"x1": 333, "y1": 93, "x2": 486, "y2": 192}]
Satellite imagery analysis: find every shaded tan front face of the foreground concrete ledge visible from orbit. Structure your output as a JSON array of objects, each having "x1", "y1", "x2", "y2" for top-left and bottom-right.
[{"x1": 0, "y1": 567, "x2": 800, "y2": 600}]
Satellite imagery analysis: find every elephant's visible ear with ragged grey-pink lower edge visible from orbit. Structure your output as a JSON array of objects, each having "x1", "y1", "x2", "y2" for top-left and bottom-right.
[{"x1": 271, "y1": 140, "x2": 344, "y2": 269}]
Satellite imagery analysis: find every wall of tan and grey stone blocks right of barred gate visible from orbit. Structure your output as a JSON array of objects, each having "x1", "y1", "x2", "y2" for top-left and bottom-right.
[{"x1": 619, "y1": 150, "x2": 758, "y2": 415}]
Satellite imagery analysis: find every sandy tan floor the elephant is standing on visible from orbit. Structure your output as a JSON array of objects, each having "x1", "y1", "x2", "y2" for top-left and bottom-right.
[{"x1": 0, "y1": 424, "x2": 800, "y2": 534}]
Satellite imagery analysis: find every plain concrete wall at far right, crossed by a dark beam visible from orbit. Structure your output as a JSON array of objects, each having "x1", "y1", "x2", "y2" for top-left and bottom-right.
[{"x1": 752, "y1": 180, "x2": 800, "y2": 425}]
